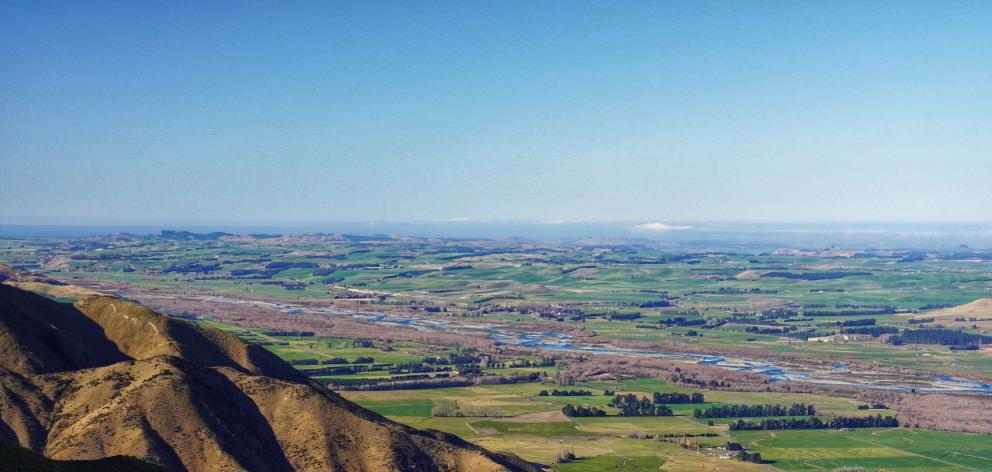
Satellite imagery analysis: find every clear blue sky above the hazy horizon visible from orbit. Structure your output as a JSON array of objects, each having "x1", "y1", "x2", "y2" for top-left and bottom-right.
[{"x1": 0, "y1": 0, "x2": 992, "y2": 224}]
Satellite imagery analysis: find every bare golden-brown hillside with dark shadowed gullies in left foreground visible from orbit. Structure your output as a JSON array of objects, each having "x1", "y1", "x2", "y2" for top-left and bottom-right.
[{"x1": 0, "y1": 284, "x2": 533, "y2": 472}]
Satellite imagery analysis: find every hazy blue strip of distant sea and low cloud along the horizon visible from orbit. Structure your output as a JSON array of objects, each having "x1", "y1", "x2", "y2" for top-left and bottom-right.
[{"x1": 0, "y1": 221, "x2": 992, "y2": 250}]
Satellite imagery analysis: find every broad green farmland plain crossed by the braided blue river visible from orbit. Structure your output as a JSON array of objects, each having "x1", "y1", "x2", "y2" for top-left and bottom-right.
[{"x1": 0, "y1": 233, "x2": 992, "y2": 471}]
